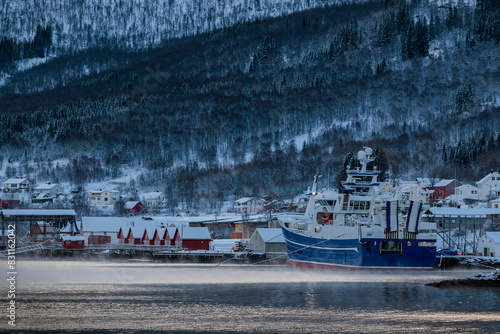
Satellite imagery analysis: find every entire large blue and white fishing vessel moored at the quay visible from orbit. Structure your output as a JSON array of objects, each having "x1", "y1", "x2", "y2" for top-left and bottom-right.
[{"x1": 278, "y1": 147, "x2": 437, "y2": 269}]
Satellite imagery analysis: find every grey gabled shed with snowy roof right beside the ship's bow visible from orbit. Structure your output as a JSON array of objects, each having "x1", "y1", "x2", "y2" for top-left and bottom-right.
[{"x1": 248, "y1": 228, "x2": 286, "y2": 258}]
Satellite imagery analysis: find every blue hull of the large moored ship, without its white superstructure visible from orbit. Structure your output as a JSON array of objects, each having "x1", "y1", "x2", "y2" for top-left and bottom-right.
[{"x1": 282, "y1": 228, "x2": 436, "y2": 269}]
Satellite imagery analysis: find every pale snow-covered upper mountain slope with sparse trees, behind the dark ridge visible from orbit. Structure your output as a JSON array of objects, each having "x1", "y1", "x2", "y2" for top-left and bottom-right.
[{"x1": 0, "y1": 0, "x2": 366, "y2": 52}]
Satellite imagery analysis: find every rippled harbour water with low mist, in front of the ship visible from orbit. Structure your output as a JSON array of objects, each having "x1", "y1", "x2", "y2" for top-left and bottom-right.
[{"x1": 0, "y1": 259, "x2": 500, "y2": 333}]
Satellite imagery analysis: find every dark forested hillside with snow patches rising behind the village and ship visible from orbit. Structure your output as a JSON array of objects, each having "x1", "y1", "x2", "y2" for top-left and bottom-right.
[{"x1": 0, "y1": 0, "x2": 500, "y2": 209}]
